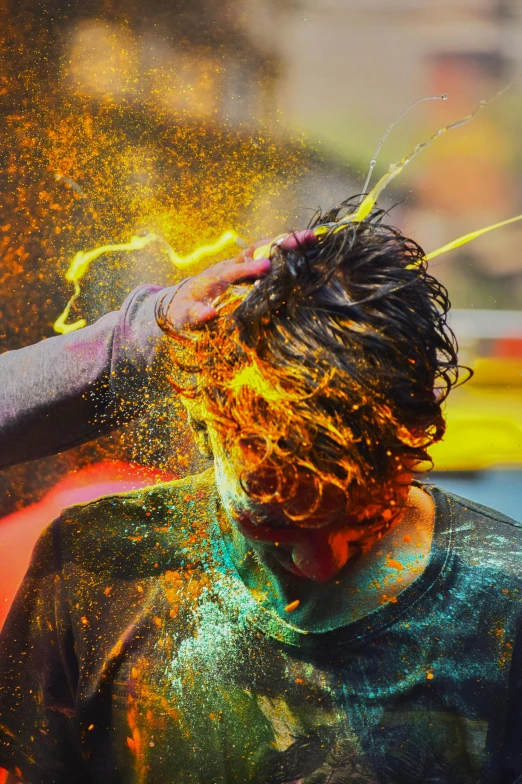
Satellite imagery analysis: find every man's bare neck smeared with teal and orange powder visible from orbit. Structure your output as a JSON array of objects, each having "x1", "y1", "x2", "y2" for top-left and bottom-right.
[{"x1": 217, "y1": 487, "x2": 434, "y2": 631}]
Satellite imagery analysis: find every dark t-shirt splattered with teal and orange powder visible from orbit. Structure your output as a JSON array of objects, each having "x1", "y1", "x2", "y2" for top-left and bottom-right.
[{"x1": 0, "y1": 472, "x2": 522, "y2": 784}]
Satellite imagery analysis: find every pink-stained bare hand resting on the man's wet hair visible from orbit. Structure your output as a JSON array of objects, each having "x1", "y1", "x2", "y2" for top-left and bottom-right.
[{"x1": 156, "y1": 229, "x2": 317, "y2": 337}]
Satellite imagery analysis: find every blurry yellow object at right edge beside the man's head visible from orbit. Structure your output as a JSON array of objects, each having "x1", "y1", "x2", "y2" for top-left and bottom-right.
[{"x1": 430, "y1": 358, "x2": 522, "y2": 471}]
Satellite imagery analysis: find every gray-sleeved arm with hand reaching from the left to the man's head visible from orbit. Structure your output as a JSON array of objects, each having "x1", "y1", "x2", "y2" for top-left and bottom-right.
[{"x1": 0, "y1": 231, "x2": 316, "y2": 470}]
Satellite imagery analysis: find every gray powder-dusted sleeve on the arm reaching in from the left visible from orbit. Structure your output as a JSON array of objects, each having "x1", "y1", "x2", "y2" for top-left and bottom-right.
[{"x1": 0, "y1": 286, "x2": 177, "y2": 469}]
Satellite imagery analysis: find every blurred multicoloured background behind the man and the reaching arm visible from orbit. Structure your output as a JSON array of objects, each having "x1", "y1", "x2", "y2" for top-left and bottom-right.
[{"x1": 0, "y1": 0, "x2": 522, "y2": 624}]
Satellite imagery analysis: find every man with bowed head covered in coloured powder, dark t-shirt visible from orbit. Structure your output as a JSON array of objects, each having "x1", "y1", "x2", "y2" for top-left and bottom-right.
[{"x1": 0, "y1": 204, "x2": 522, "y2": 784}]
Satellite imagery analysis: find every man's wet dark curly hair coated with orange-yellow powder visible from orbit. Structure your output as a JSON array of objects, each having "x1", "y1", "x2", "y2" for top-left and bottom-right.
[{"x1": 182, "y1": 200, "x2": 460, "y2": 526}]
